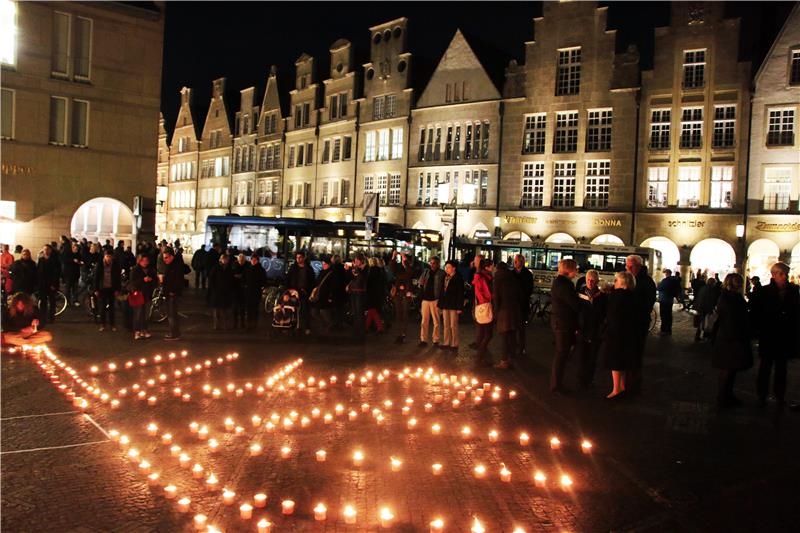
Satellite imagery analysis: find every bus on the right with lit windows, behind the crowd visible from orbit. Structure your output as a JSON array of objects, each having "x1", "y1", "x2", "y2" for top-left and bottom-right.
[{"x1": 456, "y1": 238, "x2": 663, "y2": 292}]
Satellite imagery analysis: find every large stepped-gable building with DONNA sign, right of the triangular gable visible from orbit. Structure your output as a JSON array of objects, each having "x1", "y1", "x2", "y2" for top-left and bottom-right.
[{"x1": 499, "y1": 2, "x2": 638, "y2": 255}]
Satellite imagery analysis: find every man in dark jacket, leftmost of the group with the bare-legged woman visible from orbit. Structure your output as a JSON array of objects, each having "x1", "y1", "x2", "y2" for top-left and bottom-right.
[{"x1": 550, "y1": 259, "x2": 581, "y2": 394}]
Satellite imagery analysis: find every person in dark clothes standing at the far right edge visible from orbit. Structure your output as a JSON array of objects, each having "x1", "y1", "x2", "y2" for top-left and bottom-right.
[{"x1": 753, "y1": 262, "x2": 800, "y2": 407}]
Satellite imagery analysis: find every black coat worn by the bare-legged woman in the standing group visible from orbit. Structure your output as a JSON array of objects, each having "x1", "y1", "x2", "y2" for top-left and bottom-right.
[{"x1": 599, "y1": 289, "x2": 638, "y2": 370}]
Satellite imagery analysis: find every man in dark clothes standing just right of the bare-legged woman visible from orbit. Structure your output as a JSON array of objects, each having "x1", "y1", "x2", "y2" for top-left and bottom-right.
[{"x1": 625, "y1": 254, "x2": 656, "y2": 395}]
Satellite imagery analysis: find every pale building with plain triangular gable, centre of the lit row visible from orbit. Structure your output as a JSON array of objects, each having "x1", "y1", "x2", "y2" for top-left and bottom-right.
[{"x1": 406, "y1": 30, "x2": 502, "y2": 254}]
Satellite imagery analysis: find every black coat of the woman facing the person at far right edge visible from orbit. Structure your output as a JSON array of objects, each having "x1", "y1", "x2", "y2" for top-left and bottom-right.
[{"x1": 711, "y1": 290, "x2": 753, "y2": 370}]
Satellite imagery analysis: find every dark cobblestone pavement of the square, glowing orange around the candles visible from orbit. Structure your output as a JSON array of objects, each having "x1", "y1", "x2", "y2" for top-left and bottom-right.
[{"x1": 0, "y1": 295, "x2": 800, "y2": 532}]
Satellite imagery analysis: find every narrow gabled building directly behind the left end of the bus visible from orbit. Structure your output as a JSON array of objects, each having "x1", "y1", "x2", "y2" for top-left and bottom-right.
[{"x1": 194, "y1": 78, "x2": 233, "y2": 239}]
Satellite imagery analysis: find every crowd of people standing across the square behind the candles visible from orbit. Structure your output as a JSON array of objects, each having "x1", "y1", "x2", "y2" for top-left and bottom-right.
[{"x1": 0, "y1": 231, "x2": 800, "y2": 409}]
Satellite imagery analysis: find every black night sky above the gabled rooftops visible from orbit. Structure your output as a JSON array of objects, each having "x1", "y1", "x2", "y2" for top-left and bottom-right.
[{"x1": 161, "y1": 1, "x2": 793, "y2": 137}]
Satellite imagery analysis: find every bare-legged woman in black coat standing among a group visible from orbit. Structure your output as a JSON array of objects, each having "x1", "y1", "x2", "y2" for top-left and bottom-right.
[{"x1": 600, "y1": 272, "x2": 636, "y2": 400}]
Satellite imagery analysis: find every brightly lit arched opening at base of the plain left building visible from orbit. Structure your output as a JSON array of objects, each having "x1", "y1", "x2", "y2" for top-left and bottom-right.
[{"x1": 70, "y1": 197, "x2": 136, "y2": 246}]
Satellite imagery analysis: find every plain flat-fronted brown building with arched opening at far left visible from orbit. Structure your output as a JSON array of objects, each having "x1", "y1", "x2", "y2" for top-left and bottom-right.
[{"x1": 0, "y1": 0, "x2": 164, "y2": 245}]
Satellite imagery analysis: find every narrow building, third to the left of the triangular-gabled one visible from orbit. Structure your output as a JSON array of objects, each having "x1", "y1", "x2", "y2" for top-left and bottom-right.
[{"x1": 283, "y1": 54, "x2": 319, "y2": 218}]
